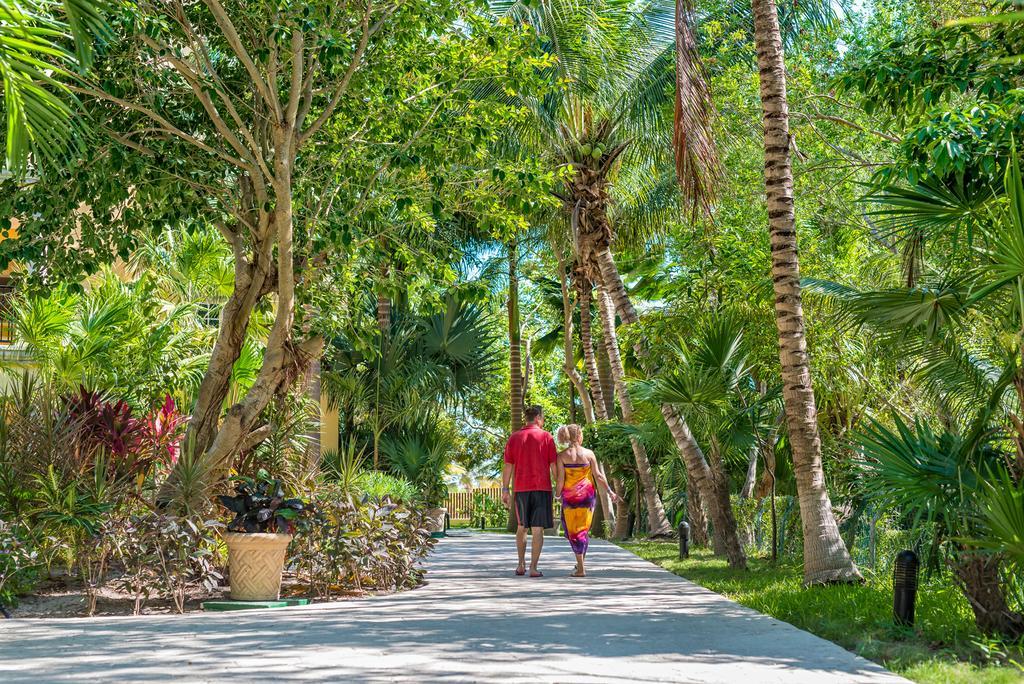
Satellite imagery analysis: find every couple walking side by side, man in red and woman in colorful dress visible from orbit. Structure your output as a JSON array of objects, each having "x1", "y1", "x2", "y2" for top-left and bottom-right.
[{"x1": 502, "y1": 407, "x2": 618, "y2": 578}]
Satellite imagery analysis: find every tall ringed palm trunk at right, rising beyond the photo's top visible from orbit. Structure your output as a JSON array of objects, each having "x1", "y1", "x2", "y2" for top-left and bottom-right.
[{"x1": 752, "y1": 0, "x2": 861, "y2": 585}]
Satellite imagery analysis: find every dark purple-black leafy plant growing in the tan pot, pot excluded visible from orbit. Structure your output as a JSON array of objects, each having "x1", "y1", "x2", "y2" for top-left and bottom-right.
[{"x1": 217, "y1": 472, "x2": 306, "y2": 535}]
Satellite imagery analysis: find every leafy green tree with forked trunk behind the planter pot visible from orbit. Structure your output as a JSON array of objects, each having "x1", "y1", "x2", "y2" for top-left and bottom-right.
[{"x1": 0, "y1": 0, "x2": 534, "y2": 489}]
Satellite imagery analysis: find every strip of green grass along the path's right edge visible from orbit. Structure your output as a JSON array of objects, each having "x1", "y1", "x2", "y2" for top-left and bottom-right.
[{"x1": 622, "y1": 542, "x2": 1024, "y2": 684}]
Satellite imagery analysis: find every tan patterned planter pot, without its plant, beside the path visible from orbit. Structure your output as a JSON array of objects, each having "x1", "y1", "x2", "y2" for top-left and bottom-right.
[{"x1": 224, "y1": 532, "x2": 292, "y2": 601}]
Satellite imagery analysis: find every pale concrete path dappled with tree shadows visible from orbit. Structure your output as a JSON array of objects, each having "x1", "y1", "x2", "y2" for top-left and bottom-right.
[{"x1": 0, "y1": 535, "x2": 905, "y2": 684}]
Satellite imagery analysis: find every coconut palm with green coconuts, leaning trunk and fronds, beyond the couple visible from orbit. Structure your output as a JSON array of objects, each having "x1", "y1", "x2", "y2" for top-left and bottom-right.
[{"x1": 494, "y1": 0, "x2": 714, "y2": 535}]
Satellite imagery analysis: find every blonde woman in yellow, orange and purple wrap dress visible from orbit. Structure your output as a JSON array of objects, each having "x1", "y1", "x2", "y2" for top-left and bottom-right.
[{"x1": 555, "y1": 424, "x2": 618, "y2": 578}]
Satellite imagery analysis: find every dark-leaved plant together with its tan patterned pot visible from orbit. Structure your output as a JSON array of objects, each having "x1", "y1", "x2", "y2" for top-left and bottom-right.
[{"x1": 217, "y1": 473, "x2": 306, "y2": 601}]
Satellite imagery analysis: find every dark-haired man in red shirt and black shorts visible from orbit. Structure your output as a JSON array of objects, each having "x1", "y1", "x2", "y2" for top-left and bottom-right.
[{"x1": 502, "y1": 407, "x2": 558, "y2": 578}]
